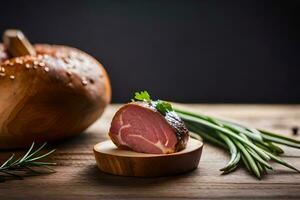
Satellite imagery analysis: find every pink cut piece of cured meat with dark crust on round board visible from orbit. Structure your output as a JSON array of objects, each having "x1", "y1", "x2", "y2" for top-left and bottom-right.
[{"x1": 109, "y1": 102, "x2": 189, "y2": 154}]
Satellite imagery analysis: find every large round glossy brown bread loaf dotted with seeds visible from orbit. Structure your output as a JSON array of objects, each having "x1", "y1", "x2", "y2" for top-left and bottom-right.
[{"x1": 0, "y1": 41, "x2": 111, "y2": 149}]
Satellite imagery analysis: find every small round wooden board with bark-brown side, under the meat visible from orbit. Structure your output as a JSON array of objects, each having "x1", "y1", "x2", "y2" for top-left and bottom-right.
[{"x1": 94, "y1": 138, "x2": 203, "y2": 177}]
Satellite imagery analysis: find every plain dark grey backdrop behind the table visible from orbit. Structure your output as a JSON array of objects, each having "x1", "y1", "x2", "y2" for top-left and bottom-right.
[{"x1": 0, "y1": 0, "x2": 300, "y2": 103}]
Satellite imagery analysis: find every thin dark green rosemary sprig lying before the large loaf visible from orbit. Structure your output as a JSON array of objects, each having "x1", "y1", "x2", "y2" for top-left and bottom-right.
[{"x1": 0, "y1": 142, "x2": 56, "y2": 179}]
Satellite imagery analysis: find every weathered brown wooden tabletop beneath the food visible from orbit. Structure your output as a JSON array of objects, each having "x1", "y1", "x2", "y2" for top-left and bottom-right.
[{"x1": 0, "y1": 104, "x2": 300, "y2": 200}]
